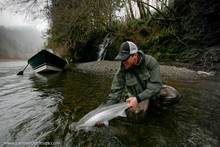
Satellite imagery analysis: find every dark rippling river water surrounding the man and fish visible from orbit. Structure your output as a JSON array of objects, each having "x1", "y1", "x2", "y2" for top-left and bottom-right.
[{"x1": 0, "y1": 61, "x2": 220, "y2": 147}]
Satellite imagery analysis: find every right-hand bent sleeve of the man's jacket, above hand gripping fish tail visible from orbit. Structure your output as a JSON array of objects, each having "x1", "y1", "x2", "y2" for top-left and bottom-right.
[{"x1": 137, "y1": 56, "x2": 162, "y2": 102}]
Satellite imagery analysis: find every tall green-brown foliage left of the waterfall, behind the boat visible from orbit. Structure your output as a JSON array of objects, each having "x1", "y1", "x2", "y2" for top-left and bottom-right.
[{"x1": 48, "y1": 0, "x2": 121, "y2": 61}]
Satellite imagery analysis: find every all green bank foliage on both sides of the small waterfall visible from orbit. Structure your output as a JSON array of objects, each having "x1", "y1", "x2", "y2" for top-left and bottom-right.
[{"x1": 45, "y1": 0, "x2": 212, "y2": 62}]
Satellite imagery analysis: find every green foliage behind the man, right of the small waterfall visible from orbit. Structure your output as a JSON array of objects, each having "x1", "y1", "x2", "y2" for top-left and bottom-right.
[{"x1": 106, "y1": 15, "x2": 202, "y2": 62}]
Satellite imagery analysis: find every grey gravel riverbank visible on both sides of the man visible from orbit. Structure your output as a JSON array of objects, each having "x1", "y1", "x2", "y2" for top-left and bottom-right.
[{"x1": 71, "y1": 61, "x2": 206, "y2": 80}]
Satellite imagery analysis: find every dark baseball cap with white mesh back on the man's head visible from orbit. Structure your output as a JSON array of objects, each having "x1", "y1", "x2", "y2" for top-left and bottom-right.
[{"x1": 115, "y1": 41, "x2": 138, "y2": 61}]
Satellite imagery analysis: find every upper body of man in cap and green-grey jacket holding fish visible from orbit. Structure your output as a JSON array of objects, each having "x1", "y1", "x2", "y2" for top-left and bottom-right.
[{"x1": 106, "y1": 41, "x2": 162, "y2": 111}]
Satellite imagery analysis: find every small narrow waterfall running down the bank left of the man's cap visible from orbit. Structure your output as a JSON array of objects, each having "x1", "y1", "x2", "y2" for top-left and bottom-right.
[{"x1": 97, "y1": 33, "x2": 115, "y2": 61}]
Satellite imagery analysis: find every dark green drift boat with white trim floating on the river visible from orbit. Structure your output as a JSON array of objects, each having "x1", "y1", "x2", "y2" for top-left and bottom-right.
[{"x1": 28, "y1": 49, "x2": 66, "y2": 73}]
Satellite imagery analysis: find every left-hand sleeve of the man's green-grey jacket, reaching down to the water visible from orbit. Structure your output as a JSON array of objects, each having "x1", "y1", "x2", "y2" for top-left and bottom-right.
[{"x1": 106, "y1": 69, "x2": 125, "y2": 105}]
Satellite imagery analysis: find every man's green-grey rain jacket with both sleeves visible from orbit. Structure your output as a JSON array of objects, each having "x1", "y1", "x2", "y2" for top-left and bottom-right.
[{"x1": 106, "y1": 50, "x2": 162, "y2": 105}]
